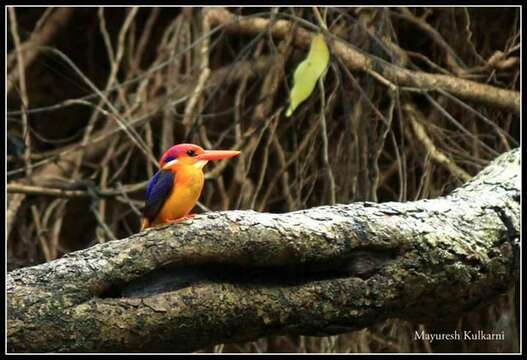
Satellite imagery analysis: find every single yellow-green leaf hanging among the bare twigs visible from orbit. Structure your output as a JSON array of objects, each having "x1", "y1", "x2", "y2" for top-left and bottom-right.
[{"x1": 285, "y1": 34, "x2": 329, "y2": 117}]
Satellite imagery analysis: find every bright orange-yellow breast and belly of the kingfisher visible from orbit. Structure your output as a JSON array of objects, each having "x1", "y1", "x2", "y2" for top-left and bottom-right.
[{"x1": 153, "y1": 165, "x2": 204, "y2": 225}]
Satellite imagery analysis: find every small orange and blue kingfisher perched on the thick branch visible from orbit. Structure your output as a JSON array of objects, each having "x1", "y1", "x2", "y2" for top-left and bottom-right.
[{"x1": 141, "y1": 144, "x2": 240, "y2": 231}]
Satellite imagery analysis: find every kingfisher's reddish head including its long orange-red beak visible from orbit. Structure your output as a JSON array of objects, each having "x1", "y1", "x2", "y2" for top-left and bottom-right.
[{"x1": 159, "y1": 144, "x2": 240, "y2": 170}]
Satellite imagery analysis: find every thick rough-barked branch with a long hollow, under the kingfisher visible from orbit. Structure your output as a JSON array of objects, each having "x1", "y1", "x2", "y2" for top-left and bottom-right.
[{"x1": 6, "y1": 149, "x2": 520, "y2": 352}]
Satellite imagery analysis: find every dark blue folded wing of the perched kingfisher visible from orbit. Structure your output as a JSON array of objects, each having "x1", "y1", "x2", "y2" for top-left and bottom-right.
[{"x1": 143, "y1": 170, "x2": 175, "y2": 222}]
